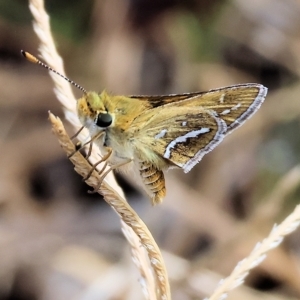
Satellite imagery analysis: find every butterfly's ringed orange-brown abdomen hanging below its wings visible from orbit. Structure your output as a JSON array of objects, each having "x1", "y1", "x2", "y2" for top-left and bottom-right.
[{"x1": 139, "y1": 162, "x2": 166, "y2": 205}]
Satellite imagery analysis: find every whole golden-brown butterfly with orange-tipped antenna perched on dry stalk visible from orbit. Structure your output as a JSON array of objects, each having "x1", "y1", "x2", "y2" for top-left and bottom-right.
[{"x1": 22, "y1": 51, "x2": 268, "y2": 204}]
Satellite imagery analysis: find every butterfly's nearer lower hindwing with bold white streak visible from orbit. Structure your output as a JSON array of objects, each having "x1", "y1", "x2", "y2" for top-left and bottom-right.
[{"x1": 132, "y1": 106, "x2": 227, "y2": 172}]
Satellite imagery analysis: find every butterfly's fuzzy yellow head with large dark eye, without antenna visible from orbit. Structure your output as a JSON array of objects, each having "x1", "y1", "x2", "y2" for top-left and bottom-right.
[{"x1": 77, "y1": 91, "x2": 113, "y2": 129}]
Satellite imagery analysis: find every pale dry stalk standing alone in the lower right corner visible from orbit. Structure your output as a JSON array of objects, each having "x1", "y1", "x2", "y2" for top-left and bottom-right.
[{"x1": 206, "y1": 205, "x2": 300, "y2": 300}]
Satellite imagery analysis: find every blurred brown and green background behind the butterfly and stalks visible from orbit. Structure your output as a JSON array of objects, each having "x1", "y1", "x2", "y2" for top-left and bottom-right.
[{"x1": 0, "y1": 0, "x2": 300, "y2": 300}]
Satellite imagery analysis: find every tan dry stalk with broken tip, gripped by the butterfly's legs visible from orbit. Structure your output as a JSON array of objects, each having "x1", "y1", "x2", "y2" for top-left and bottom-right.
[{"x1": 49, "y1": 113, "x2": 171, "y2": 300}]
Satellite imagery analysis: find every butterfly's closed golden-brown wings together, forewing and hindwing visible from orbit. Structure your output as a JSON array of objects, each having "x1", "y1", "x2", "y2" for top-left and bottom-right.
[{"x1": 131, "y1": 84, "x2": 267, "y2": 172}]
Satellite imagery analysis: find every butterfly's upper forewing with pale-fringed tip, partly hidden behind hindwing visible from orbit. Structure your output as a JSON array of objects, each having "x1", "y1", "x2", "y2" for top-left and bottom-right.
[{"x1": 131, "y1": 83, "x2": 268, "y2": 132}]
